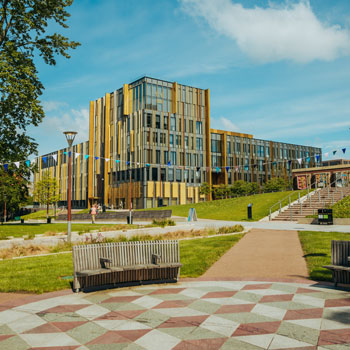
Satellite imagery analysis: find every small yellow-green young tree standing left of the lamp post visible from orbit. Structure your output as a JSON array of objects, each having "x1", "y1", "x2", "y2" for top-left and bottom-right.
[{"x1": 34, "y1": 173, "x2": 60, "y2": 218}]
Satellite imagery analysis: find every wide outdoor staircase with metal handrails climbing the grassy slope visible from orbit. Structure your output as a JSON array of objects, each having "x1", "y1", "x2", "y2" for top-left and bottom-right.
[{"x1": 272, "y1": 187, "x2": 350, "y2": 221}]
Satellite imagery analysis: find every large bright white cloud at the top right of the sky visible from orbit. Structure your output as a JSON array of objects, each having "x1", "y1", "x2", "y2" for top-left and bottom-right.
[{"x1": 180, "y1": 0, "x2": 350, "y2": 63}]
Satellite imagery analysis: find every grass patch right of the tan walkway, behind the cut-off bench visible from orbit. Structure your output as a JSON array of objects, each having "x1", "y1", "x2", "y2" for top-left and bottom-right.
[{"x1": 299, "y1": 231, "x2": 350, "y2": 281}]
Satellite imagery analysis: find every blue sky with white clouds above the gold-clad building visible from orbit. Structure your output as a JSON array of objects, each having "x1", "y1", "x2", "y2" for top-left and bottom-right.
[{"x1": 30, "y1": 0, "x2": 350, "y2": 158}]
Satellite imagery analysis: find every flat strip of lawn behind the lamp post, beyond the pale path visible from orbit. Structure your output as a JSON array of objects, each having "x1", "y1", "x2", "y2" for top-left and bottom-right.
[{"x1": 0, "y1": 223, "x2": 138, "y2": 239}]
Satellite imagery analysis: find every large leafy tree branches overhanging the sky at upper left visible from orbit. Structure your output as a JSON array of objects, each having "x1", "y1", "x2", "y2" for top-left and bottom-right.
[{"x1": 0, "y1": 0, "x2": 80, "y2": 163}]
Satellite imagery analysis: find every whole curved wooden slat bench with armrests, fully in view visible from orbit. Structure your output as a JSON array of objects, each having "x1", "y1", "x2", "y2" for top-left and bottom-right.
[{"x1": 73, "y1": 240, "x2": 182, "y2": 292}]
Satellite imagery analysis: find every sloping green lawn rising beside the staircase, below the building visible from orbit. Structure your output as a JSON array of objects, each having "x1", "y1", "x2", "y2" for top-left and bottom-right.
[{"x1": 150, "y1": 191, "x2": 306, "y2": 221}]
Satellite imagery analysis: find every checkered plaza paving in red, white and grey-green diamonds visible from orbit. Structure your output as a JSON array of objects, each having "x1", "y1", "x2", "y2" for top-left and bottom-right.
[{"x1": 0, "y1": 281, "x2": 350, "y2": 350}]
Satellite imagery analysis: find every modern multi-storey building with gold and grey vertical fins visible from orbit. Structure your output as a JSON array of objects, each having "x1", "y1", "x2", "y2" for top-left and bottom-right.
[{"x1": 35, "y1": 77, "x2": 322, "y2": 208}]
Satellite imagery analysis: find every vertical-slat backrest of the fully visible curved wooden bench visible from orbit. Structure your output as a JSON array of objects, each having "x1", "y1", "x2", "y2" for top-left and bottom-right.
[{"x1": 73, "y1": 240, "x2": 180, "y2": 272}]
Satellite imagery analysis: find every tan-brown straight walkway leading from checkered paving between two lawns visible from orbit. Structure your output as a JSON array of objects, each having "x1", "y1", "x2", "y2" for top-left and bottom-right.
[{"x1": 203, "y1": 229, "x2": 308, "y2": 279}]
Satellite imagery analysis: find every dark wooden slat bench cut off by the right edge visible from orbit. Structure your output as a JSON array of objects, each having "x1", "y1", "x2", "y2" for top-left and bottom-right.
[{"x1": 323, "y1": 241, "x2": 350, "y2": 286}]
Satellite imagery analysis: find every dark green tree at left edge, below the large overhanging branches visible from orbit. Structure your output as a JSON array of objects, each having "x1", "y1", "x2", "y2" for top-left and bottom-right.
[{"x1": 0, "y1": 170, "x2": 28, "y2": 218}]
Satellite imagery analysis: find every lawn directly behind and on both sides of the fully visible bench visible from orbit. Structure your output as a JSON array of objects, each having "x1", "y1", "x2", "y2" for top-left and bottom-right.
[{"x1": 0, "y1": 234, "x2": 243, "y2": 293}]
